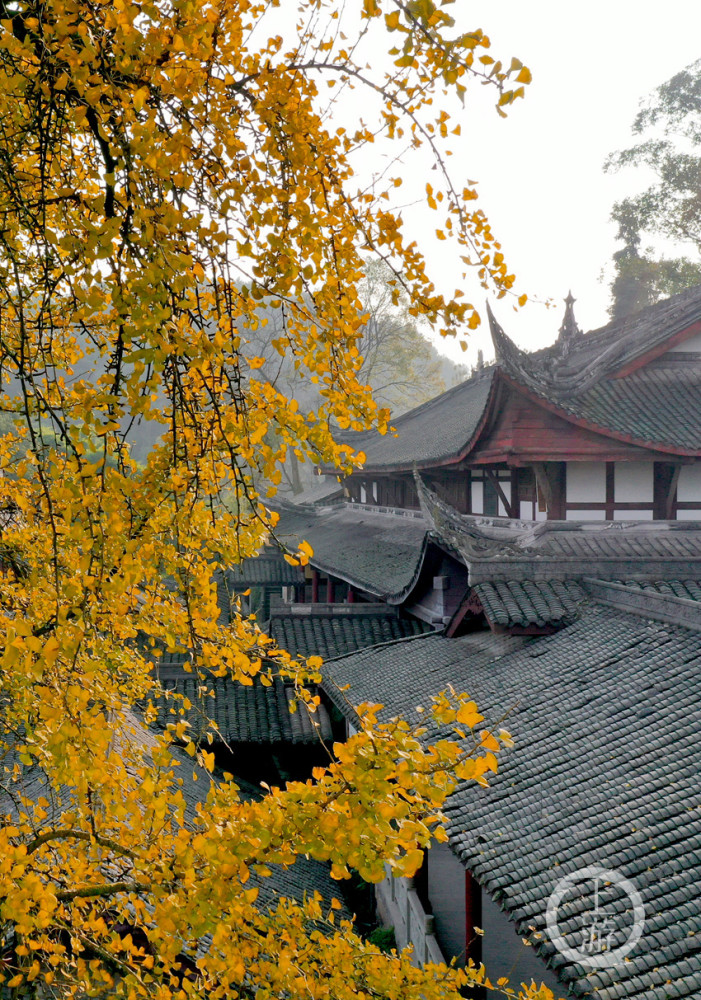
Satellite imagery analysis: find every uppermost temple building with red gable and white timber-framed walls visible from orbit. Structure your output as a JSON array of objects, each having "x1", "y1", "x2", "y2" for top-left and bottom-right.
[{"x1": 334, "y1": 288, "x2": 701, "y2": 520}]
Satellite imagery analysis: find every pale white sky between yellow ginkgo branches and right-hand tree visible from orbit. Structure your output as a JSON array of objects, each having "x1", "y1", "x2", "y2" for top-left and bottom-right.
[{"x1": 392, "y1": 0, "x2": 701, "y2": 368}]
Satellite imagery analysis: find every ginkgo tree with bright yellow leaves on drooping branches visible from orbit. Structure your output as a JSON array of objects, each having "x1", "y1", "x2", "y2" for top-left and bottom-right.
[{"x1": 0, "y1": 0, "x2": 545, "y2": 1000}]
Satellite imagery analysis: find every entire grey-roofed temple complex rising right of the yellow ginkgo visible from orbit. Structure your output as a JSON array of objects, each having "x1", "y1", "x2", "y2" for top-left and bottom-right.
[{"x1": 253, "y1": 288, "x2": 701, "y2": 1000}]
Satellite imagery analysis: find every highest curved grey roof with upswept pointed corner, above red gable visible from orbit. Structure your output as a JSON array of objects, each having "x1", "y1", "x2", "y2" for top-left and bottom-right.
[{"x1": 346, "y1": 286, "x2": 701, "y2": 474}]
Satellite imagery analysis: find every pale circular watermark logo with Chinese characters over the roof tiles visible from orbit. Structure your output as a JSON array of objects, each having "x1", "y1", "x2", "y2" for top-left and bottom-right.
[{"x1": 545, "y1": 865, "x2": 645, "y2": 969}]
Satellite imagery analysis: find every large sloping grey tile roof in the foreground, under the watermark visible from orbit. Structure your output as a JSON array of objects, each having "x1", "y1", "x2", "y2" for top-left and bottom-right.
[{"x1": 325, "y1": 605, "x2": 701, "y2": 1000}]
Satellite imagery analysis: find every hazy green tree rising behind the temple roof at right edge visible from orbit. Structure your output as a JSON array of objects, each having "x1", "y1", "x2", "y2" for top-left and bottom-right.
[{"x1": 605, "y1": 60, "x2": 701, "y2": 319}]
